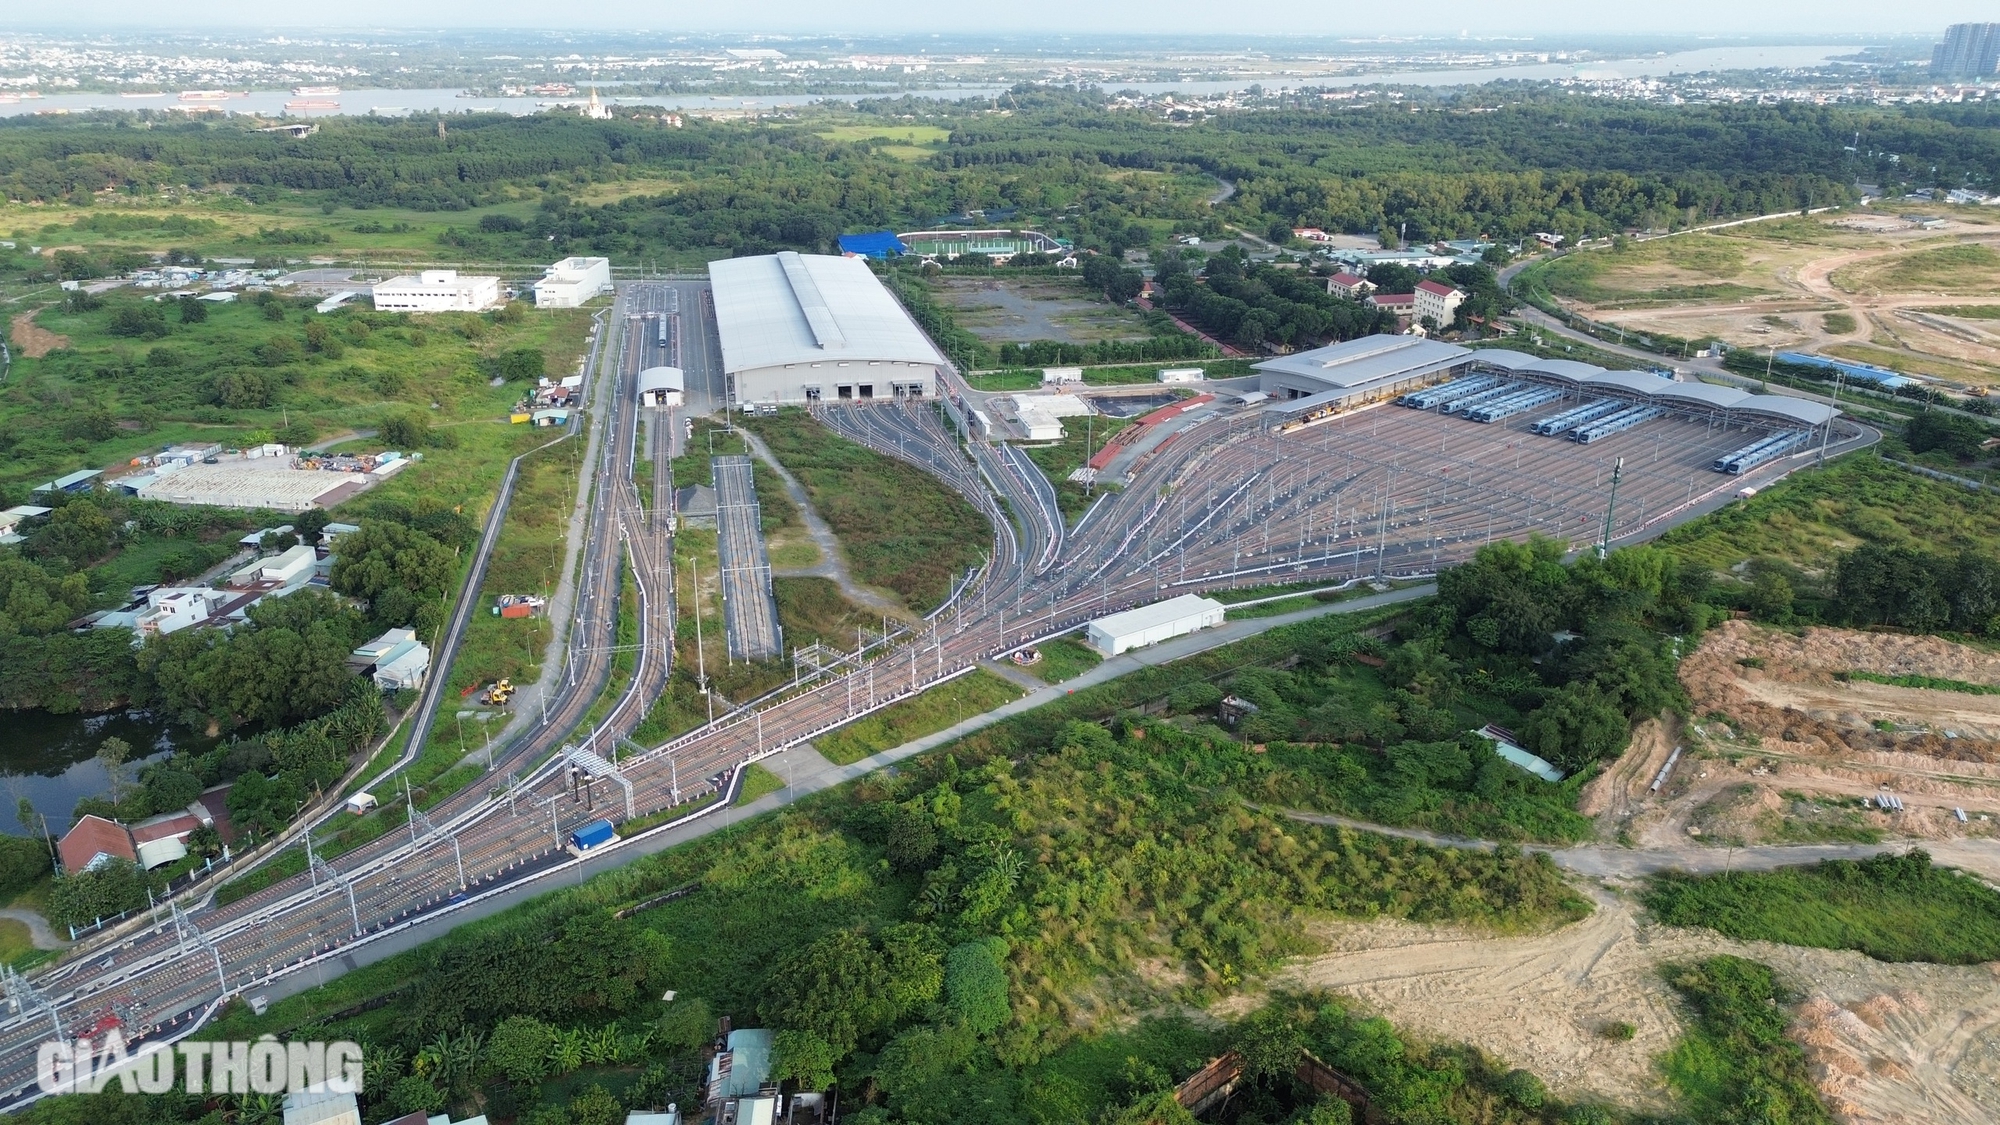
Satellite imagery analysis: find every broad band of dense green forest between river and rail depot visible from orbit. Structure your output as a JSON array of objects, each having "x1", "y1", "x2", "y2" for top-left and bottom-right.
[{"x1": 15, "y1": 88, "x2": 2000, "y2": 256}]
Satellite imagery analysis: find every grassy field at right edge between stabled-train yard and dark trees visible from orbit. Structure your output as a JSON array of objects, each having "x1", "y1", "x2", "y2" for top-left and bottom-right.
[{"x1": 1658, "y1": 454, "x2": 2000, "y2": 571}]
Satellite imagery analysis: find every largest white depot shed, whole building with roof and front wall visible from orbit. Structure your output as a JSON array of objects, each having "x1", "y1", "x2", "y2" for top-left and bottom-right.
[{"x1": 708, "y1": 250, "x2": 944, "y2": 406}]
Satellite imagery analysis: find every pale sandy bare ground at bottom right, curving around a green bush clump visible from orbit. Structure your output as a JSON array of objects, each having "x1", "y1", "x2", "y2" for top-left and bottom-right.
[{"x1": 1280, "y1": 893, "x2": 2000, "y2": 1125}]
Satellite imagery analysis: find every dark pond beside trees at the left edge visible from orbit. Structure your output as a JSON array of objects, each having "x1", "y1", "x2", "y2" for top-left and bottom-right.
[{"x1": 0, "y1": 711, "x2": 210, "y2": 835}]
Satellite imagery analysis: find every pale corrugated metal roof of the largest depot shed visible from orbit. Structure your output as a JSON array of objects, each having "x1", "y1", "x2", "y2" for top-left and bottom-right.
[{"x1": 708, "y1": 250, "x2": 944, "y2": 372}]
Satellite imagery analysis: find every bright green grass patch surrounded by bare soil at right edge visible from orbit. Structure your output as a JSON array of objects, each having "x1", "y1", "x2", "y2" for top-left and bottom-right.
[{"x1": 1646, "y1": 849, "x2": 2000, "y2": 965}]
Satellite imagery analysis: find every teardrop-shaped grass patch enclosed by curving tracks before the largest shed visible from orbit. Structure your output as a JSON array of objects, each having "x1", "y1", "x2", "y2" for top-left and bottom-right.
[{"x1": 744, "y1": 410, "x2": 992, "y2": 611}]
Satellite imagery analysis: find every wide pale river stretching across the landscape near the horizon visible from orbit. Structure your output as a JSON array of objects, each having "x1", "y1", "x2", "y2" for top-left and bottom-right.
[{"x1": 0, "y1": 44, "x2": 1860, "y2": 116}]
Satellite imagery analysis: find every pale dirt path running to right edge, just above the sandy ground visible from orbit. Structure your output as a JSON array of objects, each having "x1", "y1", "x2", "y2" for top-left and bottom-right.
[{"x1": 1274, "y1": 809, "x2": 2000, "y2": 879}]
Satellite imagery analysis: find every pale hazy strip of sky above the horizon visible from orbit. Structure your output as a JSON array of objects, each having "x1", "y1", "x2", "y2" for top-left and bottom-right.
[{"x1": 11, "y1": 0, "x2": 2000, "y2": 36}]
